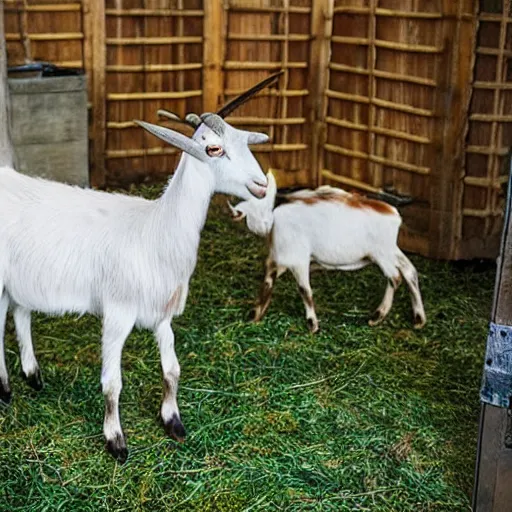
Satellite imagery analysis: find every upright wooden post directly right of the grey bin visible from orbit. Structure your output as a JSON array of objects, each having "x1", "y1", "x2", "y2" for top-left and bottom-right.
[{"x1": 84, "y1": 0, "x2": 107, "y2": 187}]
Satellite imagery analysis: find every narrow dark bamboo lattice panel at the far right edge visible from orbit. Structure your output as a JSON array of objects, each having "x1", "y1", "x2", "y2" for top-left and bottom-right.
[{"x1": 459, "y1": 0, "x2": 512, "y2": 257}]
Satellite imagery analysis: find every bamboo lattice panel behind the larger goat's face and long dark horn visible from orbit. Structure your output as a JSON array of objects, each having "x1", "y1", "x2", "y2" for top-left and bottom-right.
[{"x1": 222, "y1": 0, "x2": 312, "y2": 186}]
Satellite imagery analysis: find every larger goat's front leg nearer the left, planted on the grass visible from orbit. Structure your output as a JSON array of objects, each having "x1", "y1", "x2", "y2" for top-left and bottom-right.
[{"x1": 101, "y1": 313, "x2": 135, "y2": 463}]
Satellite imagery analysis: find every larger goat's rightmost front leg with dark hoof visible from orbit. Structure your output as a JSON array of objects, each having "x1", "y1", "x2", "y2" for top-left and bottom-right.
[{"x1": 155, "y1": 321, "x2": 186, "y2": 441}]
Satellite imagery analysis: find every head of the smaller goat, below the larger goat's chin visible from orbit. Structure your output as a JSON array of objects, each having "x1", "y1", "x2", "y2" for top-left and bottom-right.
[{"x1": 228, "y1": 171, "x2": 277, "y2": 236}]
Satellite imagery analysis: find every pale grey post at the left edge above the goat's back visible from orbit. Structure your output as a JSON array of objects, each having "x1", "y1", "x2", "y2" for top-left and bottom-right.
[{"x1": 0, "y1": 0, "x2": 14, "y2": 167}]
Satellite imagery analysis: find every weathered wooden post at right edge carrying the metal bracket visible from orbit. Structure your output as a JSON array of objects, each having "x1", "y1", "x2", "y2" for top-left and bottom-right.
[{"x1": 473, "y1": 155, "x2": 512, "y2": 512}]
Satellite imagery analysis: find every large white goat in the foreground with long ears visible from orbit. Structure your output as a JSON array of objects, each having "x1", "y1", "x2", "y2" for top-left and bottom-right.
[{"x1": 0, "y1": 114, "x2": 268, "y2": 461}]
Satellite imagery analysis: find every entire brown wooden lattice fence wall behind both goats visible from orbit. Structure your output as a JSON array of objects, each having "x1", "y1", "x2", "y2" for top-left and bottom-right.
[{"x1": 4, "y1": 0, "x2": 512, "y2": 258}]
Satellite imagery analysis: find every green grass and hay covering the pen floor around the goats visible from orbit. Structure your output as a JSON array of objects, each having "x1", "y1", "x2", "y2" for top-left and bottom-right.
[{"x1": 0, "y1": 188, "x2": 494, "y2": 512}]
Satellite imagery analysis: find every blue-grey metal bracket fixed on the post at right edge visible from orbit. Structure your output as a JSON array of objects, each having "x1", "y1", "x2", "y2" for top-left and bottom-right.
[{"x1": 480, "y1": 322, "x2": 512, "y2": 408}]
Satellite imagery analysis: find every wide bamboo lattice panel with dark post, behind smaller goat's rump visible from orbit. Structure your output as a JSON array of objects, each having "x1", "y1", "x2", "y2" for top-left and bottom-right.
[{"x1": 322, "y1": 0, "x2": 474, "y2": 256}]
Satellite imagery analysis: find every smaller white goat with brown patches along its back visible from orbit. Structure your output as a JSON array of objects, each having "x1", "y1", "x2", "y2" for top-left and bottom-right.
[{"x1": 228, "y1": 172, "x2": 426, "y2": 332}]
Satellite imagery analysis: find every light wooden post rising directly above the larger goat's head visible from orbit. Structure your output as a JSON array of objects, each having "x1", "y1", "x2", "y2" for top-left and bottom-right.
[{"x1": 203, "y1": 0, "x2": 226, "y2": 112}]
